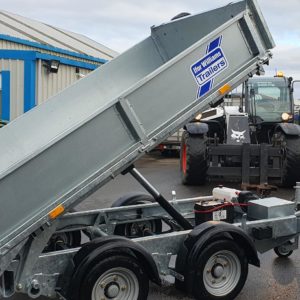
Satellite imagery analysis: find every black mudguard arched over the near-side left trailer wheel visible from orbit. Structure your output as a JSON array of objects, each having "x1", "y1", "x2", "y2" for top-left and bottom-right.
[{"x1": 67, "y1": 236, "x2": 161, "y2": 300}]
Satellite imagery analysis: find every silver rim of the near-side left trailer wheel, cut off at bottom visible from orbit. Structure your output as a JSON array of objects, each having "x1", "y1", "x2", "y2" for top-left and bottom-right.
[{"x1": 91, "y1": 268, "x2": 139, "y2": 300}]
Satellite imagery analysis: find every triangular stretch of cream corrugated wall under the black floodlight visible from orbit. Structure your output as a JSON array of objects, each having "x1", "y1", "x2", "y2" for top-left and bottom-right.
[{"x1": 36, "y1": 60, "x2": 90, "y2": 104}]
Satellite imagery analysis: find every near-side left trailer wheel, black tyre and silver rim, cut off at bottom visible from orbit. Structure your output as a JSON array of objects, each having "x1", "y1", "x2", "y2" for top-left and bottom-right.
[{"x1": 79, "y1": 255, "x2": 149, "y2": 300}]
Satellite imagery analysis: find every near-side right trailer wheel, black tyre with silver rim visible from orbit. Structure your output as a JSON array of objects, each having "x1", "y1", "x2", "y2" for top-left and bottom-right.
[{"x1": 193, "y1": 240, "x2": 248, "y2": 300}]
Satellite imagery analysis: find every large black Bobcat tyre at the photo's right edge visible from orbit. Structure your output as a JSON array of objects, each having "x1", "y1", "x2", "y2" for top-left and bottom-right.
[{"x1": 282, "y1": 135, "x2": 300, "y2": 187}]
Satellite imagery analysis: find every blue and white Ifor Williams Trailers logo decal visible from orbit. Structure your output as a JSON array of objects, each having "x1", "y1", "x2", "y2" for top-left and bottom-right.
[{"x1": 191, "y1": 36, "x2": 228, "y2": 98}]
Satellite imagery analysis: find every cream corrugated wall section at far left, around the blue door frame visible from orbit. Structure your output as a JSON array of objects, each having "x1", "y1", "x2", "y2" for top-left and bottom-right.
[{"x1": 0, "y1": 59, "x2": 24, "y2": 120}]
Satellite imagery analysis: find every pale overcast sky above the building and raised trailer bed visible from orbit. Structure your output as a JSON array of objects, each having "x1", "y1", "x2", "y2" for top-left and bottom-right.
[{"x1": 0, "y1": 0, "x2": 300, "y2": 84}]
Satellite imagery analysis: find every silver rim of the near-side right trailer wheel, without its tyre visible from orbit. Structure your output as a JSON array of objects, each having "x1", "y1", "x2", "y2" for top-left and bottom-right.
[{"x1": 203, "y1": 250, "x2": 241, "y2": 297}]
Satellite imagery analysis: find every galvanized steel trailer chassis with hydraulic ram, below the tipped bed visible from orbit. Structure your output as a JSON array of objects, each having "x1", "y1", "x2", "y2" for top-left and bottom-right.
[{"x1": 0, "y1": 168, "x2": 300, "y2": 299}]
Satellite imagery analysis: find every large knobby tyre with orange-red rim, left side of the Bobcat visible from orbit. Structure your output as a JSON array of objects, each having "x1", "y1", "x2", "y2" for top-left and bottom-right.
[{"x1": 180, "y1": 131, "x2": 208, "y2": 185}]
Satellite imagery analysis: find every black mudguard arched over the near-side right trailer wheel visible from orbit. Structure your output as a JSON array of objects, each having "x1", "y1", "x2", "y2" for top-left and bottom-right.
[{"x1": 175, "y1": 221, "x2": 260, "y2": 292}]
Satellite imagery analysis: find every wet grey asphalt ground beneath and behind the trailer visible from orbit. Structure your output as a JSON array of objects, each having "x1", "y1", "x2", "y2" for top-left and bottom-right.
[{"x1": 10, "y1": 153, "x2": 300, "y2": 300}]
